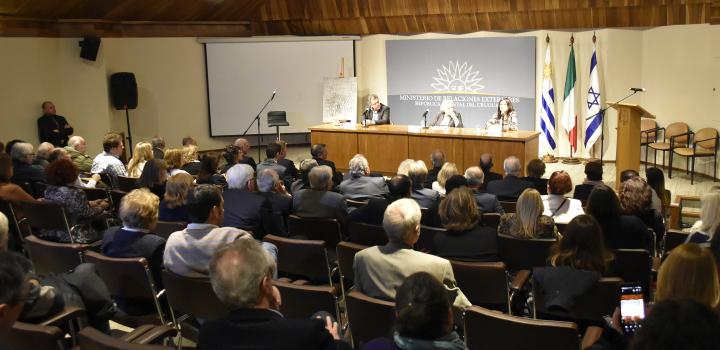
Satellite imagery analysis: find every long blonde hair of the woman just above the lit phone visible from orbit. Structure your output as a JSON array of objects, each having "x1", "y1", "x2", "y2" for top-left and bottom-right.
[{"x1": 655, "y1": 243, "x2": 720, "y2": 310}]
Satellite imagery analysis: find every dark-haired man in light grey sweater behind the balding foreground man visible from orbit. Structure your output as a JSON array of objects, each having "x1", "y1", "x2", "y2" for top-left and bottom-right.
[{"x1": 163, "y1": 185, "x2": 277, "y2": 277}]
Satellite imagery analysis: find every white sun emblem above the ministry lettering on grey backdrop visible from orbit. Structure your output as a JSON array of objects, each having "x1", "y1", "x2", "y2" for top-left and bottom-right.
[{"x1": 430, "y1": 60, "x2": 485, "y2": 93}]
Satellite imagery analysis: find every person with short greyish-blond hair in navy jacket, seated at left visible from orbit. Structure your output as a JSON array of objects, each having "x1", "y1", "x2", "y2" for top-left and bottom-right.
[{"x1": 102, "y1": 189, "x2": 167, "y2": 315}]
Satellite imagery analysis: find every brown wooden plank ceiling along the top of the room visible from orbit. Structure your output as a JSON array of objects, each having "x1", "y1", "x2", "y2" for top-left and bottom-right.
[{"x1": 0, "y1": 0, "x2": 720, "y2": 37}]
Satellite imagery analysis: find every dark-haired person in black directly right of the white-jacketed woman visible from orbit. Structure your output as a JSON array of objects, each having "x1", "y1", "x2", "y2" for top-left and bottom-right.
[{"x1": 587, "y1": 185, "x2": 652, "y2": 249}]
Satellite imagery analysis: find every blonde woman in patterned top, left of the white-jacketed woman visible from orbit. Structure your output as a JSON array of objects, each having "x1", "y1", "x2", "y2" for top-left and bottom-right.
[{"x1": 498, "y1": 188, "x2": 558, "y2": 239}]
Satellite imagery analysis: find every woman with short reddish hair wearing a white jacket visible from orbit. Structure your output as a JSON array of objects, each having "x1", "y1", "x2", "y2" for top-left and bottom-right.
[{"x1": 542, "y1": 170, "x2": 585, "y2": 224}]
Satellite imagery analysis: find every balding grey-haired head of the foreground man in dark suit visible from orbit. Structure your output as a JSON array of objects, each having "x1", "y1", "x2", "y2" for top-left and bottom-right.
[{"x1": 209, "y1": 238, "x2": 275, "y2": 308}]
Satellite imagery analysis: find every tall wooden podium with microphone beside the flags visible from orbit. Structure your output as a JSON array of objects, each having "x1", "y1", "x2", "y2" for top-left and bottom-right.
[{"x1": 607, "y1": 102, "x2": 655, "y2": 188}]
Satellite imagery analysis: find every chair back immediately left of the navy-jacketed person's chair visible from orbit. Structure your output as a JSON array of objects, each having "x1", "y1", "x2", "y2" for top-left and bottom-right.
[{"x1": 25, "y1": 235, "x2": 90, "y2": 275}]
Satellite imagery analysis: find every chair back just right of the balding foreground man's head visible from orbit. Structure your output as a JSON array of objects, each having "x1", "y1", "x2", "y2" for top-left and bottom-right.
[{"x1": 273, "y1": 280, "x2": 339, "y2": 320}]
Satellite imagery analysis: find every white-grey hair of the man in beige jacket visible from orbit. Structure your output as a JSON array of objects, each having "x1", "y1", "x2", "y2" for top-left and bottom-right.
[{"x1": 383, "y1": 198, "x2": 422, "y2": 243}]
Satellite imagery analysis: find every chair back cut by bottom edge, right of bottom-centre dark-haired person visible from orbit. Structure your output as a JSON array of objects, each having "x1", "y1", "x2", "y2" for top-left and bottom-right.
[{"x1": 465, "y1": 306, "x2": 580, "y2": 350}]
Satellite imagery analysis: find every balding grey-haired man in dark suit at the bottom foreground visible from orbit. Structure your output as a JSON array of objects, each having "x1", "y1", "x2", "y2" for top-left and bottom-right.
[{"x1": 198, "y1": 239, "x2": 351, "y2": 350}]
